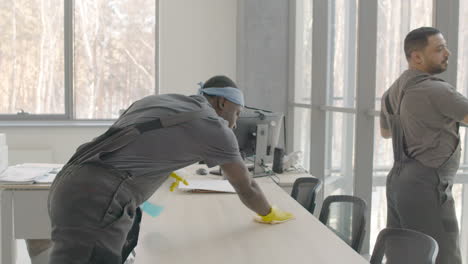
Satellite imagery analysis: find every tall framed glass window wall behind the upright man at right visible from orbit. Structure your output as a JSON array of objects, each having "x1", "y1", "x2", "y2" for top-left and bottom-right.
[{"x1": 289, "y1": 0, "x2": 468, "y2": 260}]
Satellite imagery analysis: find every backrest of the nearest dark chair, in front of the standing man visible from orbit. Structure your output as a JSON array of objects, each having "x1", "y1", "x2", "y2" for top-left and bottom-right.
[{"x1": 370, "y1": 228, "x2": 439, "y2": 264}]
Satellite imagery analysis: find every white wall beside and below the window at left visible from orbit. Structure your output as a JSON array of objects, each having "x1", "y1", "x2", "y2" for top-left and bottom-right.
[{"x1": 0, "y1": 0, "x2": 237, "y2": 165}]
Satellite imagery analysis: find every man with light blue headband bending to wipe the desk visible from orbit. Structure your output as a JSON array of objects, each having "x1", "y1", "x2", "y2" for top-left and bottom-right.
[{"x1": 49, "y1": 76, "x2": 293, "y2": 264}]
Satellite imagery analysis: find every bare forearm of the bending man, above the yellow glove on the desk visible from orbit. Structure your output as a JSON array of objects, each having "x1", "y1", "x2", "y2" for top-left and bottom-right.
[{"x1": 221, "y1": 162, "x2": 271, "y2": 215}]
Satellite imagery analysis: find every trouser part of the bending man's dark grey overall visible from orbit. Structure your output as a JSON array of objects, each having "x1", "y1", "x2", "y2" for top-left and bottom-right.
[{"x1": 49, "y1": 164, "x2": 137, "y2": 264}]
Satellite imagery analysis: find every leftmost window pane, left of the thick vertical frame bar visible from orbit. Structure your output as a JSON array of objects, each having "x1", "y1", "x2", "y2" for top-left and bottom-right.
[{"x1": 0, "y1": 0, "x2": 65, "y2": 114}]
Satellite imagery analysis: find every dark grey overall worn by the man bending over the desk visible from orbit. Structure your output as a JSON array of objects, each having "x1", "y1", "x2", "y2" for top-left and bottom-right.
[{"x1": 49, "y1": 109, "x2": 206, "y2": 264}]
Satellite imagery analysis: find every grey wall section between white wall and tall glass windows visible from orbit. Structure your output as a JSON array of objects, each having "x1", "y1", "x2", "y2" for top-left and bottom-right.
[{"x1": 237, "y1": 0, "x2": 290, "y2": 112}]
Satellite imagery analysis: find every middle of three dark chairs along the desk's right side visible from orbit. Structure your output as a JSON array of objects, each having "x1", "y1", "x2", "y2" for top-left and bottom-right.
[{"x1": 319, "y1": 195, "x2": 367, "y2": 253}]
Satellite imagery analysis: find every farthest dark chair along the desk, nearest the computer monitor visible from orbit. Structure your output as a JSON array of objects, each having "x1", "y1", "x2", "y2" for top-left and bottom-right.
[{"x1": 291, "y1": 177, "x2": 321, "y2": 214}]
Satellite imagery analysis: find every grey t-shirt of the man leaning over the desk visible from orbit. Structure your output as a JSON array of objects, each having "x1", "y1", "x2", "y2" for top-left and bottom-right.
[{"x1": 104, "y1": 94, "x2": 242, "y2": 199}]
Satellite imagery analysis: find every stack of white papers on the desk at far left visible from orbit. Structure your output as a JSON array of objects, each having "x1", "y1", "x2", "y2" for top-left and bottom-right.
[{"x1": 0, "y1": 163, "x2": 63, "y2": 184}]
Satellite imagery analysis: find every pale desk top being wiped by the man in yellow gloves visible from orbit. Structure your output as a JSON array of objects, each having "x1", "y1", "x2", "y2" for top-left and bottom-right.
[{"x1": 135, "y1": 170, "x2": 368, "y2": 264}]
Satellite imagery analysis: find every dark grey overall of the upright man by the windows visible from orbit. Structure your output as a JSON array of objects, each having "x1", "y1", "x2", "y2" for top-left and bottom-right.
[{"x1": 385, "y1": 92, "x2": 461, "y2": 264}]
